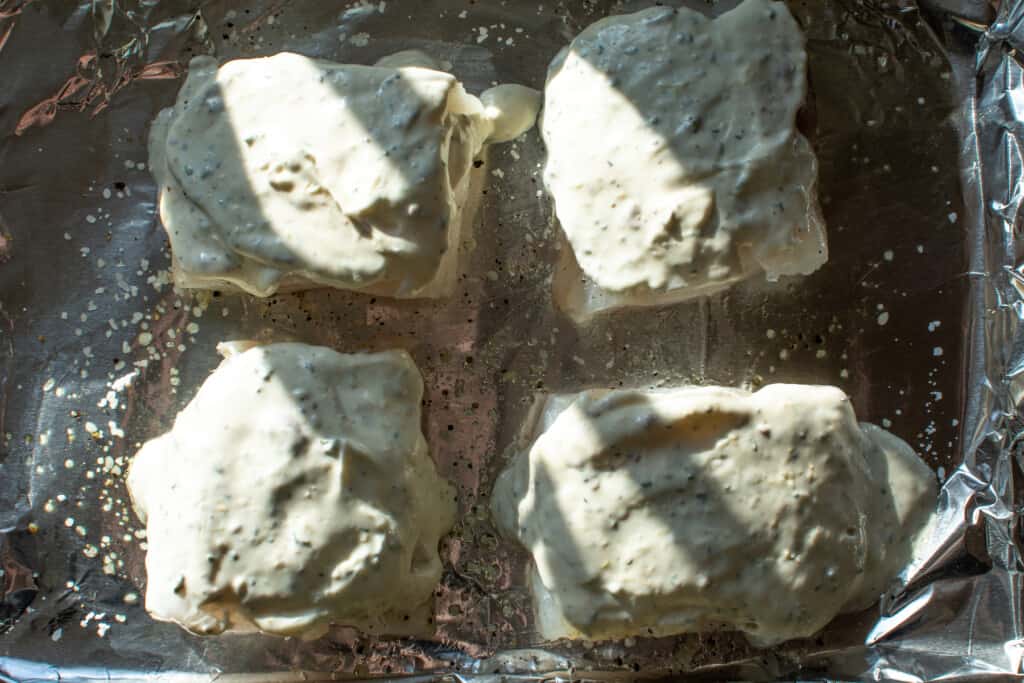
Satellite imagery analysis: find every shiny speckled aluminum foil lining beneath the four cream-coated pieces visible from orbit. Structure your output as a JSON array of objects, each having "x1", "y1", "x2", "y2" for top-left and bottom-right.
[{"x1": 0, "y1": 0, "x2": 1024, "y2": 681}]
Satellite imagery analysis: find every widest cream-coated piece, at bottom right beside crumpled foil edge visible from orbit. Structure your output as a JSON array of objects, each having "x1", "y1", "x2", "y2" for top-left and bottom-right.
[{"x1": 494, "y1": 384, "x2": 937, "y2": 645}]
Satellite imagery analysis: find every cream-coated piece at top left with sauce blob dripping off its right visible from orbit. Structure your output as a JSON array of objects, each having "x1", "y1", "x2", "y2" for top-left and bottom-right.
[{"x1": 150, "y1": 51, "x2": 538, "y2": 297}]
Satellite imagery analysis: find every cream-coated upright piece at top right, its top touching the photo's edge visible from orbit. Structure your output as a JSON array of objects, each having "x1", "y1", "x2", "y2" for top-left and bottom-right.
[{"x1": 541, "y1": 0, "x2": 827, "y2": 316}]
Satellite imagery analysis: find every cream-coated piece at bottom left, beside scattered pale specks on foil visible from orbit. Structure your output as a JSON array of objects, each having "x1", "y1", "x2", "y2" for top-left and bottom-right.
[{"x1": 128, "y1": 344, "x2": 455, "y2": 637}]
